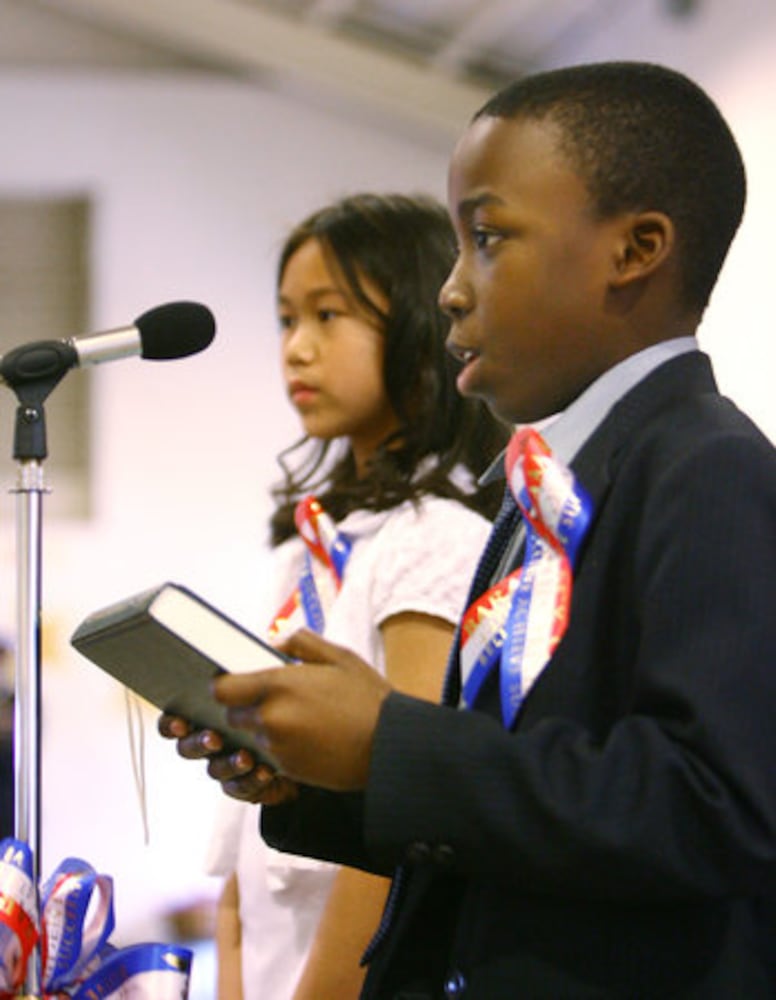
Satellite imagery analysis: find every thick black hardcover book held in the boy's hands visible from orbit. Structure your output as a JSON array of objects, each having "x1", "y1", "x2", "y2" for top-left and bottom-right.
[{"x1": 70, "y1": 583, "x2": 291, "y2": 764}]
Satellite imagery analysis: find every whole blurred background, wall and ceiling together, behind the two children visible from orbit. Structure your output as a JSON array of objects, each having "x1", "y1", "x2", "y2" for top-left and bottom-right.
[{"x1": 0, "y1": 0, "x2": 776, "y2": 998}]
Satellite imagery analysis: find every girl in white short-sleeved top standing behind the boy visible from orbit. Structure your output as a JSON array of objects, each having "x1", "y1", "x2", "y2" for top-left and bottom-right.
[{"x1": 199, "y1": 195, "x2": 507, "y2": 1000}]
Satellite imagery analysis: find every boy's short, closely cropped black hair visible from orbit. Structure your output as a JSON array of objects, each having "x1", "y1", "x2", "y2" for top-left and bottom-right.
[{"x1": 474, "y1": 62, "x2": 746, "y2": 310}]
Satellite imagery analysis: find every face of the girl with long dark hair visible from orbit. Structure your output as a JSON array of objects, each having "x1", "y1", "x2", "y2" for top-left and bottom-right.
[{"x1": 278, "y1": 239, "x2": 398, "y2": 472}]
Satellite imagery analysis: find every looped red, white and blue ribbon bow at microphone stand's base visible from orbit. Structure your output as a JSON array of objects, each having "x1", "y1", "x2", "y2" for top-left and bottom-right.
[{"x1": 0, "y1": 837, "x2": 192, "y2": 1000}]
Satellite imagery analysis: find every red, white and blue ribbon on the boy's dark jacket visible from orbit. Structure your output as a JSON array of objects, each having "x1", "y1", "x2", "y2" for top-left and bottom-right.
[{"x1": 461, "y1": 428, "x2": 592, "y2": 728}]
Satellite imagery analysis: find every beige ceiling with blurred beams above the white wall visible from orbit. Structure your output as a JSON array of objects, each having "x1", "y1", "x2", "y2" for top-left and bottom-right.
[{"x1": 0, "y1": 0, "x2": 772, "y2": 142}]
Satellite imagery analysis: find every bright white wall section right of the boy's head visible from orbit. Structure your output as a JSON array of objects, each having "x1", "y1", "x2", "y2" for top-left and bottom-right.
[{"x1": 553, "y1": 0, "x2": 776, "y2": 439}]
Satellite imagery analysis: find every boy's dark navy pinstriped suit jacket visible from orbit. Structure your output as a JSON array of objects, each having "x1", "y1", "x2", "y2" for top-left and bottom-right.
[{"x1": 262, "y1": 354, "x2": 776, "y2": 1000}]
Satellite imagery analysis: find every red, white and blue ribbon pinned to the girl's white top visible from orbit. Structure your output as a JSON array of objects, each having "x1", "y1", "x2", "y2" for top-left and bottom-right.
[{"x1": 269, "y1": 496, "x2": 352, "y2": 640}]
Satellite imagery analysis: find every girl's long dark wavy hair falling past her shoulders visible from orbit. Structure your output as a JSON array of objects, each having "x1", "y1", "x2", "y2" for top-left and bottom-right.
[{"x1": 270, "y1": 194, "x2": 509, "y2": 545}]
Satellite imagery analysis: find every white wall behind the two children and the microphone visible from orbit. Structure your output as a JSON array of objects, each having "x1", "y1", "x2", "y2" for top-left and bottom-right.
[{"x1": 0, "y1": 7, "x2": 776, "y2": 968}]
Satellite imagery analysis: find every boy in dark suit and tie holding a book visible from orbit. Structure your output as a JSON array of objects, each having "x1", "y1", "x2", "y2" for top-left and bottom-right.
[{"x1": 168, "y1": 63, "x2": 776, "y2": 1000}]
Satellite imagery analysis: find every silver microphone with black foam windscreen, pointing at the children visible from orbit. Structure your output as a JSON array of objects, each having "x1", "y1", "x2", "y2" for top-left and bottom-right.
[{"x1": 0, "y1": 302, "x2": 216, "y2": 386}]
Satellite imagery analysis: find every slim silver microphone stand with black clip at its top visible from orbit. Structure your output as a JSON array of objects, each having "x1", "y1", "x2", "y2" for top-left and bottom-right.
[{"x1": 0, "y1": 341, "x2": 75, "y2": 1000}]
